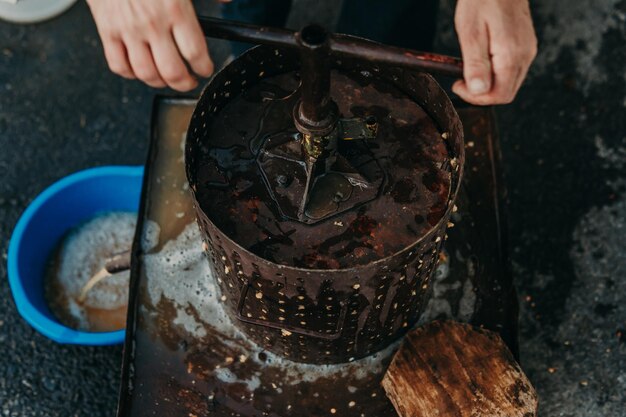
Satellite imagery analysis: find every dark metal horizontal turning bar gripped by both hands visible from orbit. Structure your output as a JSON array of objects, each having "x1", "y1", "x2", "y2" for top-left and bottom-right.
[{"x1": 199, "y1": 17, "x2": 463, "y2": 78}]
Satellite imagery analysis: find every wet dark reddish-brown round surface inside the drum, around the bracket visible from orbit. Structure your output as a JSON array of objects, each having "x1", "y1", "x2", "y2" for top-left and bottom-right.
[{"x1": 195, "y1": 71, "x2": 451, "y2": 269}]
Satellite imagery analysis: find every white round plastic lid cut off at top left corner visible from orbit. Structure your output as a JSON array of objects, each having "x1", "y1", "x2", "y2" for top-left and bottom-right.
[{"x1": 0, "y1": 0, "x2": 76, "y2": 23}]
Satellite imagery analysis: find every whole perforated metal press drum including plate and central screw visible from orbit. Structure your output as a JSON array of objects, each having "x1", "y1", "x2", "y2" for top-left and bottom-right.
[{"x1": 185, "y1": 22, "x2": 464, "y2": 364}]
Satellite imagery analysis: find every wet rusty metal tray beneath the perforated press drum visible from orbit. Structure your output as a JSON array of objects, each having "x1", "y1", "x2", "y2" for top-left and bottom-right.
[{"x1": 118, "y1": 99, "x2": 517, "y2": 417}]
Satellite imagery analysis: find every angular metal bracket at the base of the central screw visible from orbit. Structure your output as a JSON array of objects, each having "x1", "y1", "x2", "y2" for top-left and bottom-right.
[{"x1": 257, "y1": 117, "x2": 385, "y2": 224}]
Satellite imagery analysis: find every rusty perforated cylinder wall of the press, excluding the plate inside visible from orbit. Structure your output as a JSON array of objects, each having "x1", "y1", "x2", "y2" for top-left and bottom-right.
[{"x1": 186, "y1": 44, "x2": 464, "y2": 364}]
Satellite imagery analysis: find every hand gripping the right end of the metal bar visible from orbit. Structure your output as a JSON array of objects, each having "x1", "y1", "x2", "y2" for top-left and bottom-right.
[{"x1": 452, "y1": 0, "x2": 537, "y2": 105}]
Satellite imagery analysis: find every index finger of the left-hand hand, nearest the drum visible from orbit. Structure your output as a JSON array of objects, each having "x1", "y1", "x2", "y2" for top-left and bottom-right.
[{"x1": 172, "y1": 18, "x2": 213, "y2": 77}]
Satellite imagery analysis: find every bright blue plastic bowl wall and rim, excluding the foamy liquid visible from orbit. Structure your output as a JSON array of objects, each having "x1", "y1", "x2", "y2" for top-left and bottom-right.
[{"x1": 8, "y1": 166, "x2": 143, "y2": 345}]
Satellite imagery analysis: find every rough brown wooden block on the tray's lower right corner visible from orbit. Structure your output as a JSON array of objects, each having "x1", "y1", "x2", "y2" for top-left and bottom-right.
[{"x1": 382, "y1": 321, "x2": 537, "y2": 417}]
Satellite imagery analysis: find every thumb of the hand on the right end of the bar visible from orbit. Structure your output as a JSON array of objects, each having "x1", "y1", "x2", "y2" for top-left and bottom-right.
[{"x1": 458, "y1": 20, "x2": 492, "y2": 95}]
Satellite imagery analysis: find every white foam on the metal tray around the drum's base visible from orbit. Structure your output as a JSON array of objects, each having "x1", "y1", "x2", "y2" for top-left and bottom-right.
[{"x1": 144, "y1": 223, "x2": 399, "y2": 387}]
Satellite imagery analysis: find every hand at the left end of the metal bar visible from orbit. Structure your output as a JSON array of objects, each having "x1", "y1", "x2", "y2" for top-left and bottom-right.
[{"x1": 87, "y1": 0, "x2": 213, "y2": 91}]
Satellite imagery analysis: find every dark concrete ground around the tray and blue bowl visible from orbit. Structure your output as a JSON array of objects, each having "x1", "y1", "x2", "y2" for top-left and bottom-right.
[{"x1": 0, "y1": 0, "x2": 626, "y2": 417}]
